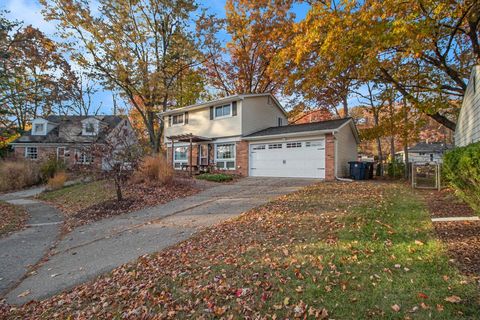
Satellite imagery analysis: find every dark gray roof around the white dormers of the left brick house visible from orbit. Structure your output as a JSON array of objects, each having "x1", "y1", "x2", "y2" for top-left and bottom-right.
[{"x1": 12, "y1": 116, "x2": 123, "y2": 143}]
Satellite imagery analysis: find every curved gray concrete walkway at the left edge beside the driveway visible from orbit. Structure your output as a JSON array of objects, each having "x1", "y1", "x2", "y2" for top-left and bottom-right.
[{"x1": 0, "y1": 188, "x2": 63, "y2": 296}]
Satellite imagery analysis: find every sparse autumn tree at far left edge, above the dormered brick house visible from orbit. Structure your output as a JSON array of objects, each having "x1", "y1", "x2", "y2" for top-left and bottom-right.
[{"x1": 0, "y1": 12, "x2": 74, "y2": 131}]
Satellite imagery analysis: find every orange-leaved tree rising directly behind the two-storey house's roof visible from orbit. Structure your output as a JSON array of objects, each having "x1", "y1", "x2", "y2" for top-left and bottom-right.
[{"x1": 201, "y1": 0, "x2": 294, "y2": 95}]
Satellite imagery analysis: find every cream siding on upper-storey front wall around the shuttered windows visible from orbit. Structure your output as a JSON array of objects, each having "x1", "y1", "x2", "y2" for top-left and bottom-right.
[{"x1": 164, "y1": 101, "x2": 242, "y2": 138}]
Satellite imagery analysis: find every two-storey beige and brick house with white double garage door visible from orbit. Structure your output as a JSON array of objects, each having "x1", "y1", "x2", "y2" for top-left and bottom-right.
[{"x1": 161, "y1": 94, "x2": 359, "y2": 180}]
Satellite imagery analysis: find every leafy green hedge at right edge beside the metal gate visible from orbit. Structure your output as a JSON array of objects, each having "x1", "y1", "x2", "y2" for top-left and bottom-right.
[{"x1": 443, "y1": 142, "x2": 480, "y2": 213}]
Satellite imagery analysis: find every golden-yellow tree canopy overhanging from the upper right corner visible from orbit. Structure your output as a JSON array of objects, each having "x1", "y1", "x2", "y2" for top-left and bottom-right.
[{"x1": 291, "y1": 0, "x2": 480, "y2": 130}]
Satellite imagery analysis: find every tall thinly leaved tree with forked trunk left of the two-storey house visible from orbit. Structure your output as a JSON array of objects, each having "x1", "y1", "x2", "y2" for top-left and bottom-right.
[{"x1": 41, "y1": 0, "x2": 211, "y2": 151}]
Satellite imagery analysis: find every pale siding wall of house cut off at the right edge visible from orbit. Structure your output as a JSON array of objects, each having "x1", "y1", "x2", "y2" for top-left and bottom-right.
[{"x1": 455, "y1": 65, "x2": 480, "y2": 147}]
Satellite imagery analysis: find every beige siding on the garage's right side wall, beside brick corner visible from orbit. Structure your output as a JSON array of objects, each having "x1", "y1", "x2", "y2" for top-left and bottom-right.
[{"x1": 335, "y1": 124, "x2": 358, "y2": 177}]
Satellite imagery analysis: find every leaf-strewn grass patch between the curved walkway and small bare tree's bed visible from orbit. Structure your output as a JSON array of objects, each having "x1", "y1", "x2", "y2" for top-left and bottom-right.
[{"x1": 38, "y1": 180, "x2": 115, "y2": 214}]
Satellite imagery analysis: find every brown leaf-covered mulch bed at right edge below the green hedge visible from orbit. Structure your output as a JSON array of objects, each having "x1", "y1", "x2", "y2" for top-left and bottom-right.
[{"x1": 421, "y1": 189, "x2": 480, "y2": 277}]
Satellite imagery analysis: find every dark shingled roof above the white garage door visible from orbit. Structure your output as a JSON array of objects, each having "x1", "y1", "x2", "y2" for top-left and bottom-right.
[{"x1": 245, "y1": 118, "x2": 351, "y2": 138}]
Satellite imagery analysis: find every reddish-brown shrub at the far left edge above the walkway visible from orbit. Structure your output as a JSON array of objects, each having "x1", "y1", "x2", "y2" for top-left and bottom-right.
[{"x1": 0, "y1": 160, "x2": 41, "y2": 192}]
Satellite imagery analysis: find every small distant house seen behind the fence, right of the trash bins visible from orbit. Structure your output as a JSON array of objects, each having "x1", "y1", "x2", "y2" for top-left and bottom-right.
[{"x1": 396, "y1": 142, "x2": 452, "y2": 163}]
